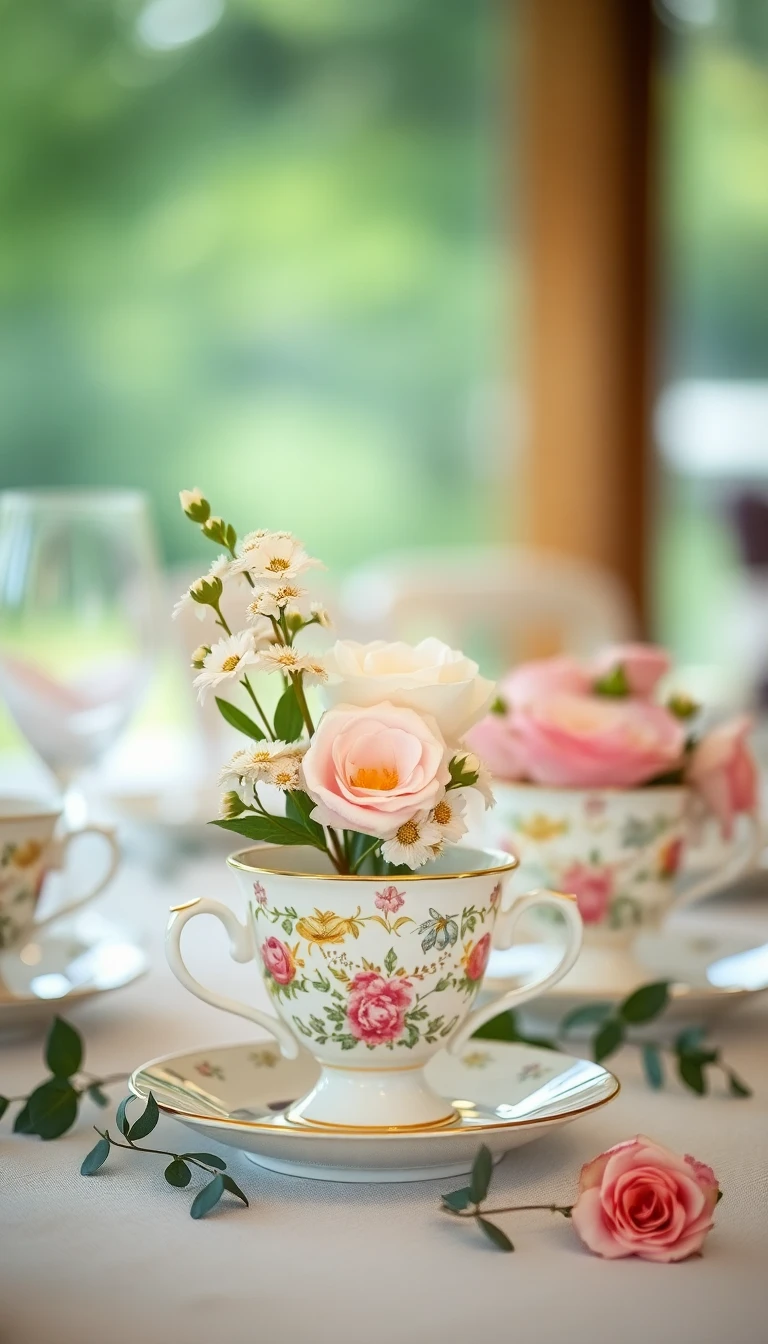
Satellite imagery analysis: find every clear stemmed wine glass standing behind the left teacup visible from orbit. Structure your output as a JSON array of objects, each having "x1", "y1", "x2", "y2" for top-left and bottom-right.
[{"x1": 0, "y1": 489, "x2": 157, "y2": 821}]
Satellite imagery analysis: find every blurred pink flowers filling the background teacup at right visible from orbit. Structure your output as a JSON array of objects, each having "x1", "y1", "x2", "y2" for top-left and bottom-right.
[{"x1": 468, "y1": 644, "x2": 757, "y2": 839}]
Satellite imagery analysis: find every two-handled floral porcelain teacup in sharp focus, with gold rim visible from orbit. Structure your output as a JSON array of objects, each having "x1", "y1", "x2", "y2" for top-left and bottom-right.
[{"x1": 165, "y1": 845, "x2": 581, "y2": 1129}]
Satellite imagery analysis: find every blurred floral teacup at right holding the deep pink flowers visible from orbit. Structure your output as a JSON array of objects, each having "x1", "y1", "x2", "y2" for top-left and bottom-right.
[{"x1": 486, "y1": 782, "x2": 761, "y2": 948}]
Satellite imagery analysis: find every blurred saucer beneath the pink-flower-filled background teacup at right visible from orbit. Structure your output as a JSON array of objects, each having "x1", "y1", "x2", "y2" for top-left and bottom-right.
[{"x1": 483, "y1": 929, "x2": 768, "y2": 1023}]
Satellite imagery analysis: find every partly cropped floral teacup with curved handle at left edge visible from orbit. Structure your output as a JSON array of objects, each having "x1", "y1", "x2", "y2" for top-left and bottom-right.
[{"x1": 0, "y1": 798, "x2": 120, "y2": 949}]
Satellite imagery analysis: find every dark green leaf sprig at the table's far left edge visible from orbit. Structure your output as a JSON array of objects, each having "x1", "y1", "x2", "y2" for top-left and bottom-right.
[{"x1": 0, "y1": 1017, "x2": 125, "y2": 1140}]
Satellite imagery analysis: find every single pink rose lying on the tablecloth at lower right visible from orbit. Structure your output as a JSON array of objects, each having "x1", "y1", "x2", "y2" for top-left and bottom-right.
[{"x1": 572, "y1": 1134, "x2": 718, "y2": 1262}]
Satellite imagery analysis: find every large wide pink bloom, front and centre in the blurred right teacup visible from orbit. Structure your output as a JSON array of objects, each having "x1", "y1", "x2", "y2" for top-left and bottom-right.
[{"x1": 514, "y1": 694, "x2": 685, "y2": 789}]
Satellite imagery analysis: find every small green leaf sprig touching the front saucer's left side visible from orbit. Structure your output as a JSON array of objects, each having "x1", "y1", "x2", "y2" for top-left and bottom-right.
[{"x1": 81, "y1": 1093, "x2": 247, "y2": 1218}]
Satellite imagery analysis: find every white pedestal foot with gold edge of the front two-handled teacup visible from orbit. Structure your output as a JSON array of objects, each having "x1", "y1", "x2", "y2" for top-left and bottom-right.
[{"x1": 285, "y1": 1064, "x2": 459, "y2": 1132}]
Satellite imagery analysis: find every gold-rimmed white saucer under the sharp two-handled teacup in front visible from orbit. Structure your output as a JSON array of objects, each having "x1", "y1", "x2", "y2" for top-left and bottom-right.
[{"x1": 129, "y1": 1040, "x2": 619, "y2": 1181}]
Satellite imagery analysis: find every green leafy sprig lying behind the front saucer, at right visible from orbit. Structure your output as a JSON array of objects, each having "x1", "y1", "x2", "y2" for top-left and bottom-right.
[{"x1": 475, "y1": 980, "x2": 752, "y2": 1097}]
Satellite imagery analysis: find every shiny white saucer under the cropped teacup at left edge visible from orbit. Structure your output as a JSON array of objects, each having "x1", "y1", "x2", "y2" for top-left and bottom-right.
[{"x1": 0, "y1": 910, "x2": 149, "y2": 1036}]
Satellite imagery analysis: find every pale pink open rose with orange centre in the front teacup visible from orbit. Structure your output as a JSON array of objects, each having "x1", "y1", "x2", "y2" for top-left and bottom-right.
[{"x1": 303, "y1": 702, "x2": 451, "y2": 840}]
